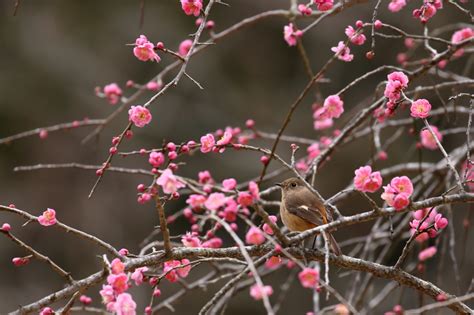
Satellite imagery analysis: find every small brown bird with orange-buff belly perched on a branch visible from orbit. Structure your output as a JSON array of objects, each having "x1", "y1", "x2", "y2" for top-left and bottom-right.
[{"x1": 276, "y1": 177, "x2": 342, "y2": 256}]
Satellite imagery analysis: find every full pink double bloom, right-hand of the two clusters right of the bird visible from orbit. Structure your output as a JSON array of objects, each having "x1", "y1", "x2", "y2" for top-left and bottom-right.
[{"x1": 381, "y1": 176, "x2": 413, "y2": 210}]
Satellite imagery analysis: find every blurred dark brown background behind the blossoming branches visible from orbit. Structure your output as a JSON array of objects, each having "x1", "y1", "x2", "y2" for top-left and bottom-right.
[{"x1": 0, "y1": 0, "x2": 474, "y2": 314}]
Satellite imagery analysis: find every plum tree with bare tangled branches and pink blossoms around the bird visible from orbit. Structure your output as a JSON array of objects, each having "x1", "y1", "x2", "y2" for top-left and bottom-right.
[{"x1": 0, "y1": 0, "x2": 474, "y2": 315}]
